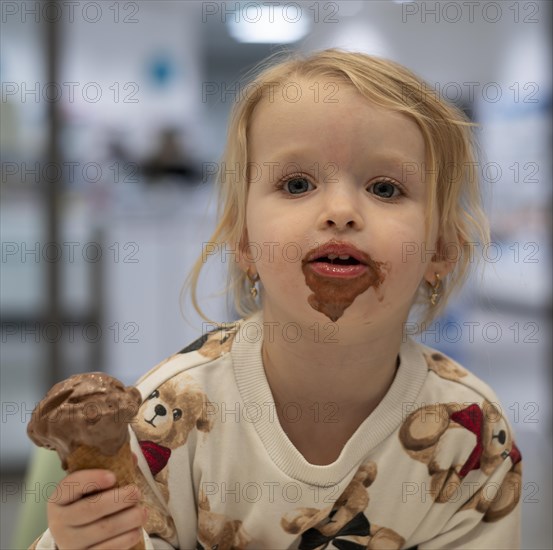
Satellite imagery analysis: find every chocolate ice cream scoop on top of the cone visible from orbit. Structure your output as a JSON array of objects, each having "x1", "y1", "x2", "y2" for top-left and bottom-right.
[{"x1": 27, "y1": 372, "x2": 141, "y2": 470}]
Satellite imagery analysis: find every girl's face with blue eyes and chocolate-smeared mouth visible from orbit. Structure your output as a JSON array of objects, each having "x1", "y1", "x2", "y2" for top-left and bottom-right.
[{"x1": 242, "y1": 79, "x2": 443, "y2": 328}]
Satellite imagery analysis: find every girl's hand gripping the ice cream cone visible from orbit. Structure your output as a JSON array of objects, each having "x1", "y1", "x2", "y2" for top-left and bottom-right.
[{"x1": 48, "y1": 470, "x2": 146, "y2": 550}]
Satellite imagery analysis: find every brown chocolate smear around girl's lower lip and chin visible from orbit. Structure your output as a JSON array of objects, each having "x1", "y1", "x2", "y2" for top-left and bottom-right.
[{"x1": 302, "y1": 258, "x2": 390, "y2": 322}]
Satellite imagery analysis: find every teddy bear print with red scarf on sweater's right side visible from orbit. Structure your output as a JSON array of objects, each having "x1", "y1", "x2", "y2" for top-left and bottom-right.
[{"x1": 399, "y1": 401, "x2": 521, "y2": 521}]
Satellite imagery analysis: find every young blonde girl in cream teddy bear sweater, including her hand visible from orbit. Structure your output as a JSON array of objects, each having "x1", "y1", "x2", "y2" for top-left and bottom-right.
[{"x1": 36, "y1": 49, "x2": 521, "y2": 550}]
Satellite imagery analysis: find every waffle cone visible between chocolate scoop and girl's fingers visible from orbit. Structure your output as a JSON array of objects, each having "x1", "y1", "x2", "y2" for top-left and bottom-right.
[{"x1": 67, "y1": 442, "x2": 145, "y2": 550}]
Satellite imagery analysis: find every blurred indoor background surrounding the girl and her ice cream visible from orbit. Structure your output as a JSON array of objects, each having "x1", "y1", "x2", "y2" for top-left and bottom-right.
[{"x1": 0, "y1": 0, "x2": 553, "y2": 549}]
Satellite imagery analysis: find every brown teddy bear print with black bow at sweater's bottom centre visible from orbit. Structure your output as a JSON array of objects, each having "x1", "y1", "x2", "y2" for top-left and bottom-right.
[{"x1": 280, "y1": 462, "x2": 405, "y2": 550}]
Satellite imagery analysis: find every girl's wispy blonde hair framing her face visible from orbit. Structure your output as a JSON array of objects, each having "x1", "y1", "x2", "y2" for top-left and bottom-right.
[{"x1": 185, "y1": 48, "x2": 489, "y2": 324}]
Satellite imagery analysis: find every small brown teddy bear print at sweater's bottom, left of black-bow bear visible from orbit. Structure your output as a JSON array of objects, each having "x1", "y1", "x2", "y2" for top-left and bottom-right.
[{"x1": 196, "y1": 489, "x2": 251, "y2": 550}]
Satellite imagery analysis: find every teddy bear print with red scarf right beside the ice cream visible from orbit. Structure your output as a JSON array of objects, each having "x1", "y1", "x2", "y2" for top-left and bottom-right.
[{"x1": 134, "y1": 373, "x2": 212, "y2": 540}]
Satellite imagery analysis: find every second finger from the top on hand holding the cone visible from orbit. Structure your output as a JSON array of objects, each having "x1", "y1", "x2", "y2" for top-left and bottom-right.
[{"x1": 64, "y1": 485, "x2": 142, "y2": 527}]
